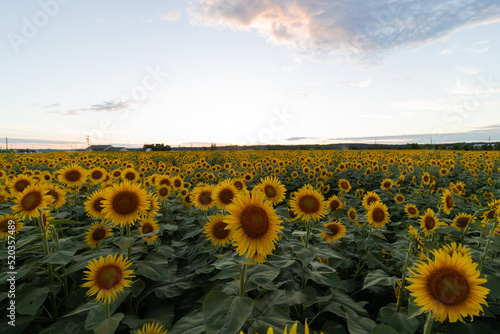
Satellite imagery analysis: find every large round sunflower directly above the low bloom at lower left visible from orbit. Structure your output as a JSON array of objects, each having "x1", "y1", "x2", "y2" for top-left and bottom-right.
[{"x1": 101, "y1": 182, "x2": 149, "y2": 227}]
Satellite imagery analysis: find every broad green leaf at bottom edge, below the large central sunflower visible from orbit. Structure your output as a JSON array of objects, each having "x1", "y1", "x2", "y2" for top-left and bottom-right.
[{"x1": 203, "y1": 291, "x2": 253, "y2": 334}]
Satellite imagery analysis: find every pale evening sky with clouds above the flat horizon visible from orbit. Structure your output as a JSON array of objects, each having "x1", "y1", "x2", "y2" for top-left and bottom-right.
[{"x1": 0, "y1": 0, "x2": 500, "y2": 149}]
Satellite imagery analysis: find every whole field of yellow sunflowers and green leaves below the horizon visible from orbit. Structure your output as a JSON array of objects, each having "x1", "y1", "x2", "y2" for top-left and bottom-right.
[{"x1": 0, "y1": 150, "x2": 500, "y2": 334}]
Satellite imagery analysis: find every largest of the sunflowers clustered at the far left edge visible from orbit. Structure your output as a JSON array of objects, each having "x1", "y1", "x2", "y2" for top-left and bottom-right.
[{"x1": 12, "y1": 185, "x2": 52, "y2": 219}]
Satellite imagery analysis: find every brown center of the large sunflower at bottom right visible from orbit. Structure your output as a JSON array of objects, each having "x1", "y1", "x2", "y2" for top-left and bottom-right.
[{"x1": 427, "y1": 268, "x2": 469, "y2": 305}]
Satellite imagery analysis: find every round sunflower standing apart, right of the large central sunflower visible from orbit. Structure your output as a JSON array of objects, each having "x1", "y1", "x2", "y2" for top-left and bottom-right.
[{"x1": 289, "y1": 184, "x2": 327, "y2": 222}]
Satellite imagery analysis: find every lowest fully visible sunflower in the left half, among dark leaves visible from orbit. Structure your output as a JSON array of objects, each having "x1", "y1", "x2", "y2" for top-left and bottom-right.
[{"x1": 81, "y1": 254, "x2": 134, "y2": 303}]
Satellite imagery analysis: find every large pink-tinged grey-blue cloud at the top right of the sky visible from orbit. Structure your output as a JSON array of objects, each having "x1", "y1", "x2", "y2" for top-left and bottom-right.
[{"x1": 188, "y1": 0, "x2": 500, "y2": 59}]
